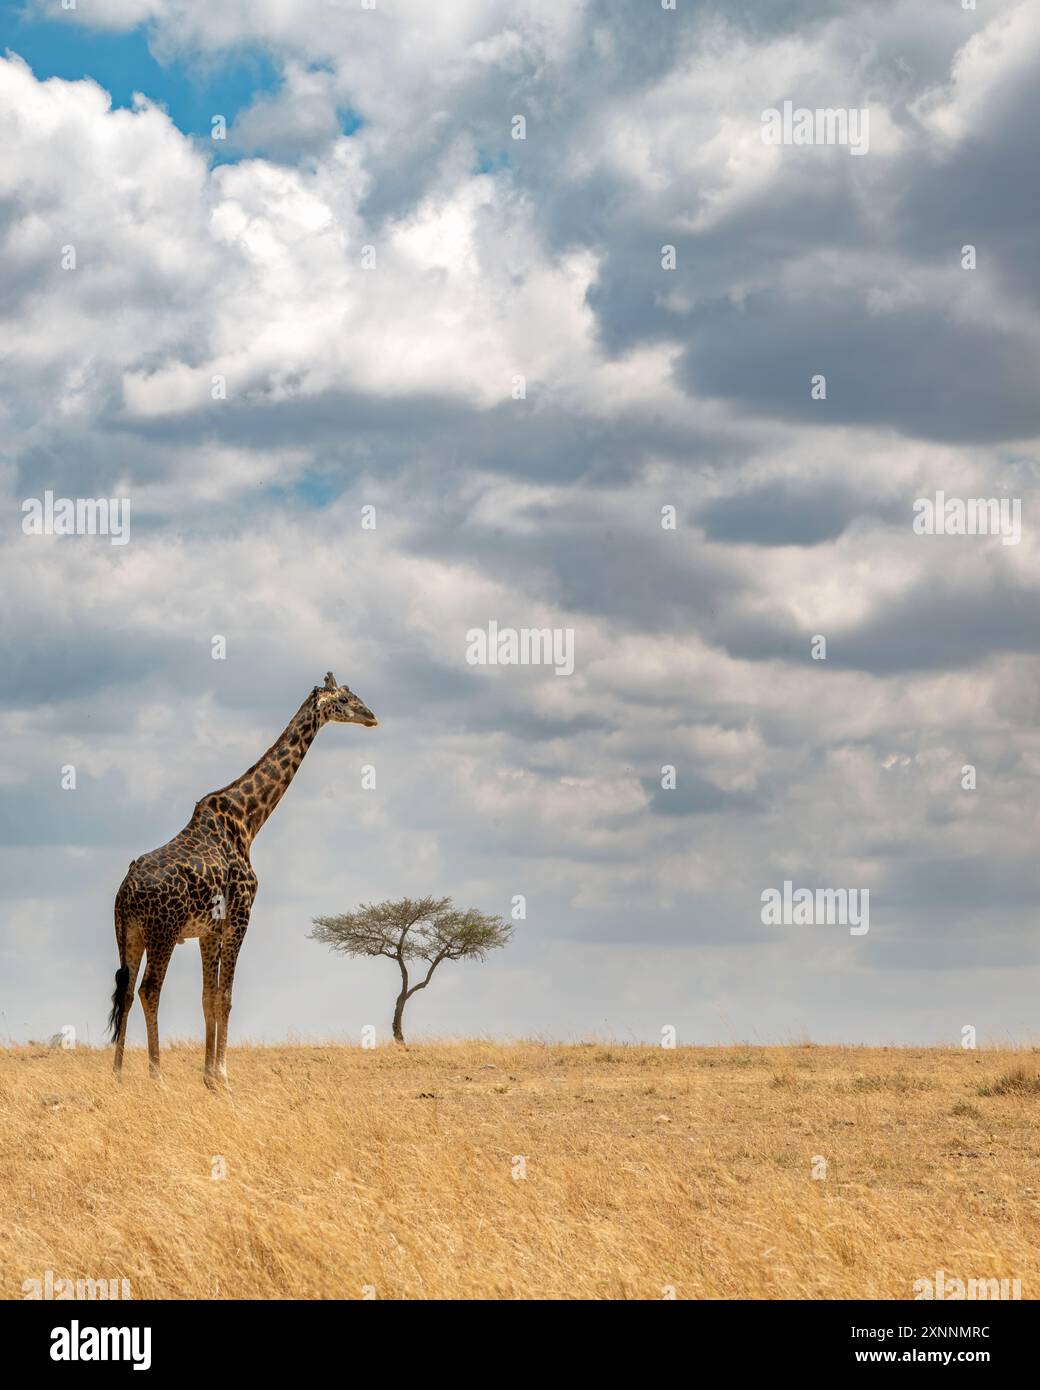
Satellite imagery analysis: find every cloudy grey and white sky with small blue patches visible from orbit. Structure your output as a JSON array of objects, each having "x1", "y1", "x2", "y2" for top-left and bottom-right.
[{"x1": 0, "y1": 0, "x2": 1040, "y2": 1045}]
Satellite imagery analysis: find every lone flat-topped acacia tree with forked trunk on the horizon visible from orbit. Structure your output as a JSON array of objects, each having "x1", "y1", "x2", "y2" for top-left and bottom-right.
[{"x1": 307, "y1": 898, "x2": 513, "y2": 1043}]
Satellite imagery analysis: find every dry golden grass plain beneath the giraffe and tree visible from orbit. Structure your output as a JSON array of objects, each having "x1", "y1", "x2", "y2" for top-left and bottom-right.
[{"x1": 0, "y1": 1043, "x2": 1040, "y2": 1298}]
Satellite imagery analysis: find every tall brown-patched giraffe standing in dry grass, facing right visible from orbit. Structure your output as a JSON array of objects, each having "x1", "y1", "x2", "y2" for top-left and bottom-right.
[{"x1": 108, "y1": 671, "x2": 378, "y2": 1091}]
